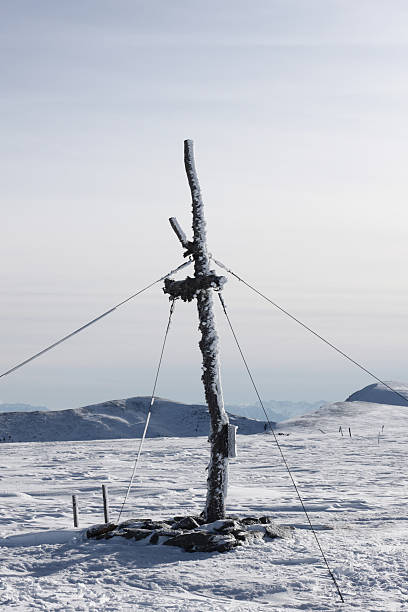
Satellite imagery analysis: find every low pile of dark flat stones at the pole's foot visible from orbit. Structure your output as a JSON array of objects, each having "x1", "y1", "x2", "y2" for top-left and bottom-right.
[{"x1": 86, "y1": 516, "x2": 293, "y2": 552}]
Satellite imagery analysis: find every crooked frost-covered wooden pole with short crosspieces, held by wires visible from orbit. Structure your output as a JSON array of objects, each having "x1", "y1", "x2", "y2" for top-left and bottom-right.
[{"x1": 165, "y1": 140, "x2": 229, "y2": 522}]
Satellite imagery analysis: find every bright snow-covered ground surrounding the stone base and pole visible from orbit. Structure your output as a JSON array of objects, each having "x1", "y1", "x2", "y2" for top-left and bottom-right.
[{"x1": 0, "y1": 402, "x2": 408, "y2": 612}]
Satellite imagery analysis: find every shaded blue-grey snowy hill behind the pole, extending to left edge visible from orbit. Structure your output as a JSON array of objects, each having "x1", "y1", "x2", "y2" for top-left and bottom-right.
[{"x1": 0, "y1": 397, "x2": 266, "y2": 442}]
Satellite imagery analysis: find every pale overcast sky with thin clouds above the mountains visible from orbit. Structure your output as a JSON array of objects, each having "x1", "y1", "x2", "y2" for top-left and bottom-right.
[{"x1": 0, "y1": 0, "x2": 408, "y2": 408}]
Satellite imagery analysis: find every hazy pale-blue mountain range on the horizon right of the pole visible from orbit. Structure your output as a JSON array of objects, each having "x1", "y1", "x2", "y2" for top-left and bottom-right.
[{"x1": 226, "y1": 400, "x2": 327, "y2": 421}]
